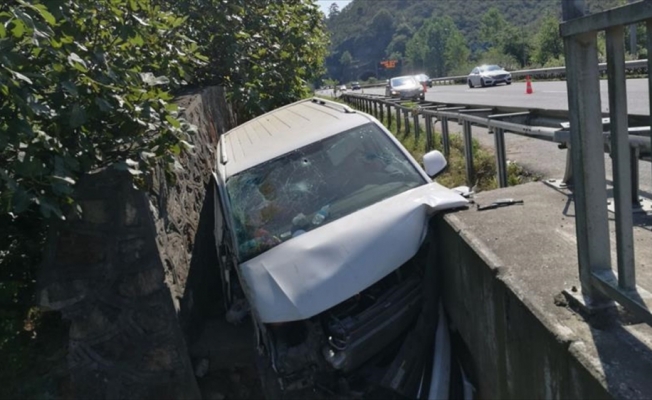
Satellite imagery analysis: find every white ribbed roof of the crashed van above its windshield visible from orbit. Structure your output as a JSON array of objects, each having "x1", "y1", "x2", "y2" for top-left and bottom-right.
[{"x1": 217, "y1": 98, "x2": 370, "y2": 178}]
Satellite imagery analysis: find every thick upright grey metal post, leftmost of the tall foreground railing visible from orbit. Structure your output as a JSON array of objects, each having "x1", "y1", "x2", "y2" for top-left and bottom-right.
[{"x1": 562, "y1": 0, "x2": 611, "y2": 305}]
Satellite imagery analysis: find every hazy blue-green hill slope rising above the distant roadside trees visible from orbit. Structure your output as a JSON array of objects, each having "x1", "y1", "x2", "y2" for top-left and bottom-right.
[{"x1": 326, "y1": 0, "x2": 623, "y2": 80}]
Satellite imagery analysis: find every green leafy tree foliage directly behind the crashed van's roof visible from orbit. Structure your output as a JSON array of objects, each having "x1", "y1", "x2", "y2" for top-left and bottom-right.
[{"x1": 162, "y1": 0, "x2": 327, "y2": 121}]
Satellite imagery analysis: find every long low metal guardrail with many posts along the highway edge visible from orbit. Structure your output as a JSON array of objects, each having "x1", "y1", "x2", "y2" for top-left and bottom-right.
[{"x1": 341, "y1": 93, "x2": 652, "y2": 192}]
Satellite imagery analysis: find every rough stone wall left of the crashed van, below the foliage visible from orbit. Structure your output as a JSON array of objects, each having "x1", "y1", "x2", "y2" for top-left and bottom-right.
[{"x1": 38, "y1": 88, "x2": 235, "y2": 399}]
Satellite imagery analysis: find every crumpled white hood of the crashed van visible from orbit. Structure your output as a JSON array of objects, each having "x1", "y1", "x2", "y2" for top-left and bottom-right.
[{"x1": 238, "y1": 182, "x2": 467, "y2": 323}]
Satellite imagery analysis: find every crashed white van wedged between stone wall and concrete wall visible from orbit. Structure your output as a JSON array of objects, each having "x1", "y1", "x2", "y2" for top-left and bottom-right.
[{"x1": 215, "y1": 99, "x2": 467, "y2": 398}]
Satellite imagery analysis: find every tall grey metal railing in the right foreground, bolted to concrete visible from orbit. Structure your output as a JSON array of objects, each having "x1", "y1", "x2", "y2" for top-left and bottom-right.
[{"x1": 560, "y1": 0, "x2": 652, "y2": 324}]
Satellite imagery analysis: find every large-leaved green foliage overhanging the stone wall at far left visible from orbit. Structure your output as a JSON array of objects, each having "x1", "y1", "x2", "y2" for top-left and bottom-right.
[{"x1": 0, "y1": 0, "x2": 198, "y2": 218}]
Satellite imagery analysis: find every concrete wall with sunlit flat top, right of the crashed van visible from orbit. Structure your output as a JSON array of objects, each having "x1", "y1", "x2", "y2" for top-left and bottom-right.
[{"x1": 435, "y1": 182, "x2": 652, "y2": 399}]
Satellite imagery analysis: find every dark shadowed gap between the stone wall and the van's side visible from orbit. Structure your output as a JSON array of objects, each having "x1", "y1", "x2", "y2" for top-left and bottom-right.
[{"x1": 180, "y1": 180, "x2": 263, "y2": 400}]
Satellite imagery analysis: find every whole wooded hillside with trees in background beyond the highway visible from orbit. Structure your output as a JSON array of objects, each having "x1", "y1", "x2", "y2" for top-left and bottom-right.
[{"x1": 326, "y1": 0, "x2": 628, "y2": 82}]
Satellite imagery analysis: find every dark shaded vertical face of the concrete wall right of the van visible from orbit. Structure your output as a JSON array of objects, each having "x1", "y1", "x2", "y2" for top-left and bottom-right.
[{"x1": 438, "y1": 219, "x2": 610, "y2": 399}]
